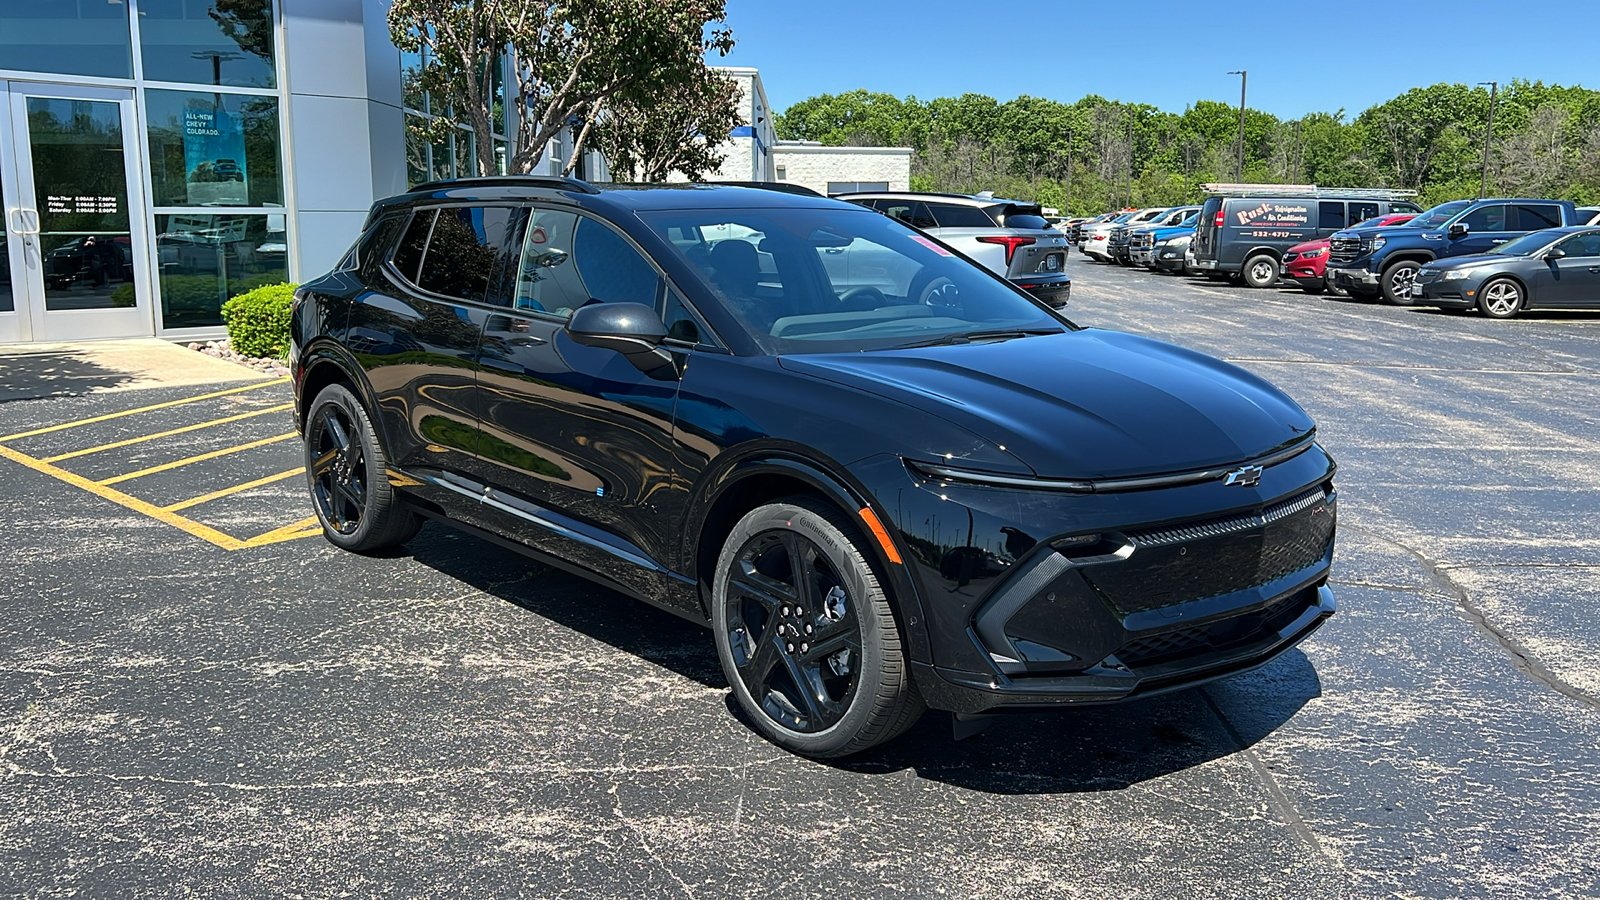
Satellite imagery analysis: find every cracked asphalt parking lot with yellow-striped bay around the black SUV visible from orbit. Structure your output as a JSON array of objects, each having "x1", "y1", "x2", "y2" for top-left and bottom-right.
[{"x1": 0, "y1": 261, "x2": 1600, "y2": 898}]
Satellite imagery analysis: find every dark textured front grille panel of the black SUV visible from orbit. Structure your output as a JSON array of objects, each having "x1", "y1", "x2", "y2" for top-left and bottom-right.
[{"x1": 1083, "y1": 487, "x2": 1334, "y2": 615}]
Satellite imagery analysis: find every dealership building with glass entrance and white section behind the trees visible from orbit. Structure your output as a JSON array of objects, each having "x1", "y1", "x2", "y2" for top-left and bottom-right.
[{"x1": 0, "y1": 0, "x2": 910, "y2": 343}]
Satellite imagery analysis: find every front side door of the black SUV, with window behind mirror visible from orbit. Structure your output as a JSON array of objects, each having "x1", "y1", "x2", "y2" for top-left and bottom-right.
[{"x1": 478, "y1": 207, "x2": 684, "y2": 599}]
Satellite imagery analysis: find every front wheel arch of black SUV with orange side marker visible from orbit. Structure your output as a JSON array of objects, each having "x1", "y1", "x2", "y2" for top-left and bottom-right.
[{"x1": 680, "y1": 448, "x2": 931, "y2": 661}]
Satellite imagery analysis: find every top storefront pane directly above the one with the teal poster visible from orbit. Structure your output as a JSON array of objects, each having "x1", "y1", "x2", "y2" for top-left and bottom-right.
[{"x1": 139, "y1": 0, "x2": 277, "y2": 88}]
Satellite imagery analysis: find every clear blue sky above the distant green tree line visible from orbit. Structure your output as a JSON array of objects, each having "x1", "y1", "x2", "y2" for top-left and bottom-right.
[{"x1": 714, "y1": 0, "x2": 1600, "y2": 119}]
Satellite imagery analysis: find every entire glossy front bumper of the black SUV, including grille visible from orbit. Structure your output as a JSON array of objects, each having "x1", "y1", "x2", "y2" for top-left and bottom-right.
[{"x1": 858, "y1": 447, "x2": 1336, "y2": 713}]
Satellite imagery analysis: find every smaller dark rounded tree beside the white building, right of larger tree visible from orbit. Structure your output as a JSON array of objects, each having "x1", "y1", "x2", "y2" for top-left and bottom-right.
[{"x1": 594, "y1": 67, "x2": 744, "y2": 181}]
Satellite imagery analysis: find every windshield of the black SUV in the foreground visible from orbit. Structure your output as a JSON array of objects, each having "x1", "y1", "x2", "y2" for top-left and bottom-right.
[{"x1": 640, "y1": 208, "x2": 1072, "y2": 354}]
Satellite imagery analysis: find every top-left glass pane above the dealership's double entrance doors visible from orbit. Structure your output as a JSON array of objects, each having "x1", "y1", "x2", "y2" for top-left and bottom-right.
[{"x1": 0, "y1": 0, "x2": 133, "y2": 82}]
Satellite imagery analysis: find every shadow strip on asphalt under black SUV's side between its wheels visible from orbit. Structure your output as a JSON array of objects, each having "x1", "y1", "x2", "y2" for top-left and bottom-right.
[{"x1": 397, "y1": 522, "x2": 728, "y2": 689}]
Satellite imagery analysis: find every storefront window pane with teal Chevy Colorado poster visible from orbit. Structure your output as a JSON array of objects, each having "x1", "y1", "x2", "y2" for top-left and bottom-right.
[{"x1": 144, "y1": 90, "x2": 283, "y2": 207}]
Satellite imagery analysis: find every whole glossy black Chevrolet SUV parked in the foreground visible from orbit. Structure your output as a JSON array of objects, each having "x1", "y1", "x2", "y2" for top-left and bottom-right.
[{"x1": 291, "y1": 176, "x2": 1334, "y2": 756}]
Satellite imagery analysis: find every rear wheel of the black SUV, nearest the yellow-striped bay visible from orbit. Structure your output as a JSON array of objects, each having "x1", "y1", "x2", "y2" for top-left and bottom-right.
[{"x1": 302, "y1": 384, "x2": 422, "y2": 552}]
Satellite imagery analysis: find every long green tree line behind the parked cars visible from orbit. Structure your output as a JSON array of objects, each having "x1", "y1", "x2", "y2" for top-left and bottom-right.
[{"x1": 776, "y1": 80, "x2": 1600, "y2": 215}]
